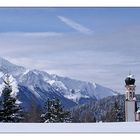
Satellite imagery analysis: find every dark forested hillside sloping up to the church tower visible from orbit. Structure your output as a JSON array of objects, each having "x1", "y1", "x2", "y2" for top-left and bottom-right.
[{"x1": 71, "y1": 95, "x2": 140, "y2": 122}]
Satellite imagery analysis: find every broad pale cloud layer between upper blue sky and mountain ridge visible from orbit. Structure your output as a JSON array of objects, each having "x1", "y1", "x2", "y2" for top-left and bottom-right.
[{"x1": 0, "y1": 26, "x2": 140, "y2": 91}]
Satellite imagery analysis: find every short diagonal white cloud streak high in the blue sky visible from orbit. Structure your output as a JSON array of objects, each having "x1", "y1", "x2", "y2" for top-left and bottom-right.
[{"x1": 58, "y1": 16, "x2": 93, "y2": 35}]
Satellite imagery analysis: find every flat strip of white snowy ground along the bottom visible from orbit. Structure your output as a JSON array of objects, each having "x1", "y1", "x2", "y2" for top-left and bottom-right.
[{"x1": 0, "y1": 122, "x2": 140, "y2": 133}]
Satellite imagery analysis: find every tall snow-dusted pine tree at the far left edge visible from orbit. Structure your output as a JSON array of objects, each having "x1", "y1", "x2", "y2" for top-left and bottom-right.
[{"x1": 0, "y1": 75, "x2": 23, "y2": 122}]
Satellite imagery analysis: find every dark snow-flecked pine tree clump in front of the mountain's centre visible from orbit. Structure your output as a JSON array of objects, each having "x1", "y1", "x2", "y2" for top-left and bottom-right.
[{"x1": 41, "y1": 99, "x2": 71, "y2": 123}]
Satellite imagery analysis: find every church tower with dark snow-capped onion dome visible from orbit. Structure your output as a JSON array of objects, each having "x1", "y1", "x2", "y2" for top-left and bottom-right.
[{"x1": 125, "y1": 74, "x2": 136, "y2": 122}]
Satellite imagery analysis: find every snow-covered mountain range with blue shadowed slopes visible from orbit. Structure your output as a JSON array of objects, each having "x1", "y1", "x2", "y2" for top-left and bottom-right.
[{"x1": 0, "y1": 58, "x2": 117, "y2": 108}]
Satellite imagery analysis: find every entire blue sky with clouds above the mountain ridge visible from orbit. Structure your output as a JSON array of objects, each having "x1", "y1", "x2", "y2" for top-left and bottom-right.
[{"x1": 0, "y1": 8, "x2": 140, "y2": 93}]
